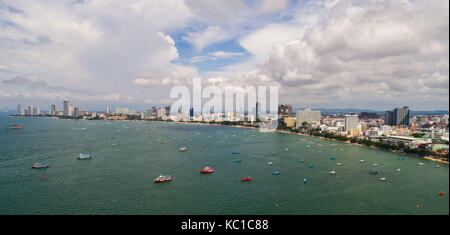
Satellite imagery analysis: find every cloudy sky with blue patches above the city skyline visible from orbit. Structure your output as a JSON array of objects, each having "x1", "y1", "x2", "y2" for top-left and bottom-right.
[{"x1": 0, "y1": 0, "x2": 449, "y2": 110}]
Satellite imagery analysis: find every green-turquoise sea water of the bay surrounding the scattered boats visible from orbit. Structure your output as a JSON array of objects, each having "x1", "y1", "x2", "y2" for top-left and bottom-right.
[{"x1": 0, "y1": 116, "x2": 449, "y2": 214}]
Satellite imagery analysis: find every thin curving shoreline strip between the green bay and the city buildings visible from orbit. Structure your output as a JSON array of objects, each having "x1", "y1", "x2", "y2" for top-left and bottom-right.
[{"x1": 8, "y1": 115, "x2": 449, "y2": 165}]
